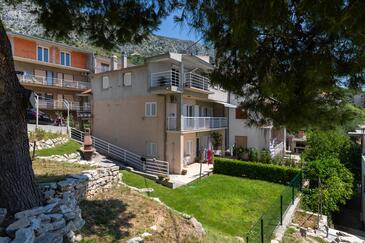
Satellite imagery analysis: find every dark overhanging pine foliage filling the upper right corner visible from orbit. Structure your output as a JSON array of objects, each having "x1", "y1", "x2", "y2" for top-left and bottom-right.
[{"x1": 180, "y1": 0, "x2": 365, "y2": 130}]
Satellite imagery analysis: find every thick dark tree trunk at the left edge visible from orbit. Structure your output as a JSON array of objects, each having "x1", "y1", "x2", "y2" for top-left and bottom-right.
[{"x1": 0, "y1": 21, "x2": 42, "y2": 213}]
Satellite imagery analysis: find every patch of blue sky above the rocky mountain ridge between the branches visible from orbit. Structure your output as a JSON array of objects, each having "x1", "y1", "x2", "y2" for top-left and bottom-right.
[{"x1": 154, "y1": 12, "x2": 200, "y2": 41}]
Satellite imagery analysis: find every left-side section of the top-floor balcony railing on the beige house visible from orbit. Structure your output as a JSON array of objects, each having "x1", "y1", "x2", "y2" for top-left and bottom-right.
[{"x1": 151, "y1": 70, "x2": 180, "y2": 88}]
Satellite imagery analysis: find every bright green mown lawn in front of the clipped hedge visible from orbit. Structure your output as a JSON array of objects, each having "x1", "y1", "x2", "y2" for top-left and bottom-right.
[{"x1": 122, "y1": 171, "x2": 285, "y2": 237}]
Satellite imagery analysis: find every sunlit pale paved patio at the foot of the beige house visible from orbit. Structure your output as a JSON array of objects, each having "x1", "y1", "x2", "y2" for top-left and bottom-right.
[{"x1": 169, "y1": 163, "x2": 213, "y2": 188}]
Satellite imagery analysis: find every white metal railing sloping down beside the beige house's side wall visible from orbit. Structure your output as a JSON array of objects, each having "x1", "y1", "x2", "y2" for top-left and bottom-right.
[{"x1": 70, "y1": 127, "x2": 169, "y2": 175}]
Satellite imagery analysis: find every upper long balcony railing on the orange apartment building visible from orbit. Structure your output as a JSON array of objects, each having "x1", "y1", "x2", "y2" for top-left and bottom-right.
[{"x1": 18, "y1": 74, "x2": 91, "y2": 89}]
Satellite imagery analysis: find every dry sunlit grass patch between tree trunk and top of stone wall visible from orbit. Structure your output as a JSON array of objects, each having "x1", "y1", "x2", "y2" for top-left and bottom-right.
[{"x1": 33, "y1": 159, "x2": 94, "y2": 183}]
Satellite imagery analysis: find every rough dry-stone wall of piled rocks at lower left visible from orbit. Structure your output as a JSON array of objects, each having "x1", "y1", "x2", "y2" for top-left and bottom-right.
[{"x1": 0, "y1": 163, "x2": 121, "y2": 243}]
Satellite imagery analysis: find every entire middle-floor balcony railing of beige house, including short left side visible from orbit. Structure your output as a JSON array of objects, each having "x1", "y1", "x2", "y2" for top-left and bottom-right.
[{"x1": 167, "y1": 117, "x2": 228, "y2": 131}]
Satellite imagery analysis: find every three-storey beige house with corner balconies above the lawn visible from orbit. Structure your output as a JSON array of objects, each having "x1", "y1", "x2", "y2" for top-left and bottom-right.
[{"x1": 92, "y1": 53, "x2": 235, "y2": 174}]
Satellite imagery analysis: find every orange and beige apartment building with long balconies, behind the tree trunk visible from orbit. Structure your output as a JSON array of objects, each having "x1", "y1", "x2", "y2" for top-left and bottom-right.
[{"x1": 7, "y1": 32, "x2": 120, "y2": 129}]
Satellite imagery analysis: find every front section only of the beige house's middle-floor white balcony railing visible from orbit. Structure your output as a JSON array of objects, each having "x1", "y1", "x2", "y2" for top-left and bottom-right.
[{"x1": 182, "y1": 117, "x2": 228, "y2": 131}]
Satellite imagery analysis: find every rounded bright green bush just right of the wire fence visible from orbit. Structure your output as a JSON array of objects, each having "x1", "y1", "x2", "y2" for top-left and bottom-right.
[{"x1": 303, "y1": 158, "x2": 353, "y2": 215}]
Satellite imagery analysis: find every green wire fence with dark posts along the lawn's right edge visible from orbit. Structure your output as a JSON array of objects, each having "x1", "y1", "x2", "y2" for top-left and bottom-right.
[{"x1": 245, "y1": 173, "x2": 302, "y2": 243}]
